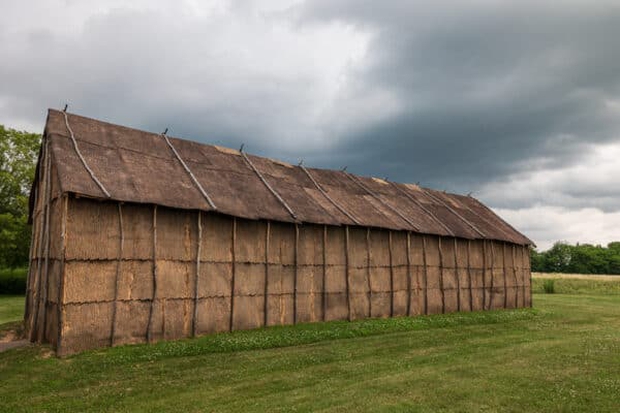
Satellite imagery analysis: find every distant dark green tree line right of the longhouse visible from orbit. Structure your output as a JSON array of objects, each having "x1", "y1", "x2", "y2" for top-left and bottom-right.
[{"x1": 531, "y1": 241, "x2": 620, "y2": 274}]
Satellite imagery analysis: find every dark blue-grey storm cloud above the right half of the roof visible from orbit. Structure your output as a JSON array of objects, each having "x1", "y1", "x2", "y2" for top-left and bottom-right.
[{"x1": 299, "y1": 0, "x2": 620, "y2": 191}]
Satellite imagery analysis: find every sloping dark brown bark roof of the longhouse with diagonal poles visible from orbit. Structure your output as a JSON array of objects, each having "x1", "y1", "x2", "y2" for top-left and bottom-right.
[{"x1": 32, "y1": 109, "x2": 532, "y2": 245}]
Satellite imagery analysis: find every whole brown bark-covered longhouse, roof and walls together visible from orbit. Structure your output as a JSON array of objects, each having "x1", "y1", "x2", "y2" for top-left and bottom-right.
[{"x1": 25, "y1": 111, "x2": 531, "y2": 355}]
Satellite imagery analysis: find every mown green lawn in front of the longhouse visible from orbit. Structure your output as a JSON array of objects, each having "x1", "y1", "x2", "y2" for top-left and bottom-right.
[{"x1": 0, "y1": 280, "x2": 620, "y2": 412}]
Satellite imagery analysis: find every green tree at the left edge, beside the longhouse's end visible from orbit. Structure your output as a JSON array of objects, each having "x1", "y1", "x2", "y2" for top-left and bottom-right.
[{"x1": 0, "y1": 125, "x2": 41, "y2": 268}]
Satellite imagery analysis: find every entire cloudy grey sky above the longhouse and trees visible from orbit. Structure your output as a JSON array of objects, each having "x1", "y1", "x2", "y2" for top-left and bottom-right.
[{"x1": 0, "y1": 0, "x2": 620, "y2": 249}]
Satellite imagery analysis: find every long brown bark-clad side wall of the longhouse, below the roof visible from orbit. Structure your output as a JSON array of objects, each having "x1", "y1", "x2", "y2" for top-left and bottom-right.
[{"x1": 38, "y1": 198, "x2": 531, "y2": 354}]
